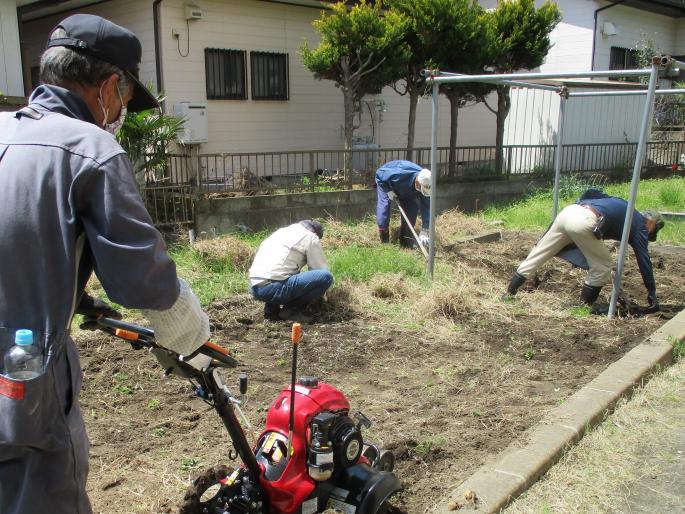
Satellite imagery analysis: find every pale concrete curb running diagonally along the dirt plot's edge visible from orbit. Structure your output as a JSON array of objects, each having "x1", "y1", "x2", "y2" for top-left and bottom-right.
[{"x1": 427, "y1": 311, "x2": 685, "y2": 514}]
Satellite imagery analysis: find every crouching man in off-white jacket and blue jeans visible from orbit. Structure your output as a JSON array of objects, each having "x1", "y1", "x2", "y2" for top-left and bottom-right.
[{"x1": 249, "y1": 220, "x2": 333, "y2": 322}]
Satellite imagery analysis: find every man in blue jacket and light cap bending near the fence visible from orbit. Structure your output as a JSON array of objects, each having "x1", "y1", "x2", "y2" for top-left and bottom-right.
[{"x1": 376, "y1": 161, "x2": 431, "y2": 248}]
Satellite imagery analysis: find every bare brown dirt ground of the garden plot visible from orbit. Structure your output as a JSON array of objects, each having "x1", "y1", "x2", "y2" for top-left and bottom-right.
[{"x1": 75, "y1": 229, "x2": 685, "y2": 514}]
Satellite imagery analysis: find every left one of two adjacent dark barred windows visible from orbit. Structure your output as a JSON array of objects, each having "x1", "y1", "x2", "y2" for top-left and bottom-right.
[{"x1": 205, "y1": 48, "x2": 247, "y2": 100}]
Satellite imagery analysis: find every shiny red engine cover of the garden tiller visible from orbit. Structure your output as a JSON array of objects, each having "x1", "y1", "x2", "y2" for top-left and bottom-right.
[{"x1": 259, "y1": 382, "x2": 350, "y2": 514}]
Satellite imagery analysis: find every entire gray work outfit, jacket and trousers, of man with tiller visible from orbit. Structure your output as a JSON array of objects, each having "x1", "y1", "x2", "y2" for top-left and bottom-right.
[{"x1": 0, "y1": 86, "x2": 179, "y2": 514}]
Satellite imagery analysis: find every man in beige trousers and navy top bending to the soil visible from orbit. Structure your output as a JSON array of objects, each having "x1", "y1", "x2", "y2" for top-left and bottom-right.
[{"x1": 507, "y1": 189, "x2": 664, "y2": 310}]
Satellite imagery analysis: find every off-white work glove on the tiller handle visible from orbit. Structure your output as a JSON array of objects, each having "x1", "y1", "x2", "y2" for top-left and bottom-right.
[{"x1": 143, "y1": 279, "x2": 209, "y2": 360}]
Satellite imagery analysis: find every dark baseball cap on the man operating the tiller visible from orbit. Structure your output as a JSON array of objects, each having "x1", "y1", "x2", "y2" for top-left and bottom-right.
[{"x1": 47, "y1": 14, "x2": 159, "y2": 112}]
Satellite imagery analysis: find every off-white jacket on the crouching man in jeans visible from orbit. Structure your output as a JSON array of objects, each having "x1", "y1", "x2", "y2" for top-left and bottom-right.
[{"x1": 250, "y1": 223, "x2": 328, "y2": 285}]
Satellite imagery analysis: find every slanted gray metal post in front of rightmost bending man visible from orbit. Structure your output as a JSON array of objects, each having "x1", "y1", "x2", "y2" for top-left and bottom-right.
[{"x1": 609, "y1": 59, "x2": 660, "y2": 318}]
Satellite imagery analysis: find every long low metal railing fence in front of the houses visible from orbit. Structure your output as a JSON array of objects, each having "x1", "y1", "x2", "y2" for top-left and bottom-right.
[{"x1": 141, "y1": 141, "x2": 685, "y2": 225}]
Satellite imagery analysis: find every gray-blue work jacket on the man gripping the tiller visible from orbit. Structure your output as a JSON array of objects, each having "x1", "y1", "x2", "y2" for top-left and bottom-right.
[{"x1": 0, "y1": 86, "x2": 179, "y2": 331}]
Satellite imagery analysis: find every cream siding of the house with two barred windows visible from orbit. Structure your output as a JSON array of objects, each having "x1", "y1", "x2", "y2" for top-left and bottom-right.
[{"x1": 162, "y1": 0, "x2": 494, "y2": 153}]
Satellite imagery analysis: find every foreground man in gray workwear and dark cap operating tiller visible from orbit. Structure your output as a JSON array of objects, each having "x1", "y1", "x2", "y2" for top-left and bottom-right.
[{"x1": 0, "y1": 14, "x2": 209, "y2": 514}]
